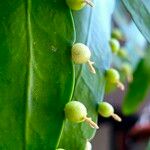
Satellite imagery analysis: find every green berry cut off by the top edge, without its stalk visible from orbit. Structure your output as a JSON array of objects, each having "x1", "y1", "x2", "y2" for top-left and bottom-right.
[{"x1": 66, "y1": 0, "x2": 86, "y2": 10}]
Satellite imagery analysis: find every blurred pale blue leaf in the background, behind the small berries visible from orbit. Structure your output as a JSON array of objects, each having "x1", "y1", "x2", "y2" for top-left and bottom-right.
[{"x1": 113, "y1": 0, "x2": 146, "y2": 69}]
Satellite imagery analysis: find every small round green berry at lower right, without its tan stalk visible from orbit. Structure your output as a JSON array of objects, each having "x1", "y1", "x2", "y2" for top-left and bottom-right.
[{"x1": 98, "y1": 102, "x2": 114, "y2": 117}]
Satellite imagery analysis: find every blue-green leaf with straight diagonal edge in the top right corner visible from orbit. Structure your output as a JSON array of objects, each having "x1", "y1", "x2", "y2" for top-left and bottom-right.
[{"x1": 122, "y1": 0, "x2": 150, "y2": 42}]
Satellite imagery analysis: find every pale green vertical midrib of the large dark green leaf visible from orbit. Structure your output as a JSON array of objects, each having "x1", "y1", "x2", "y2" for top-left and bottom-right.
[{"x1": 24, "y1": 0, "x2": 33, "y2": 150}]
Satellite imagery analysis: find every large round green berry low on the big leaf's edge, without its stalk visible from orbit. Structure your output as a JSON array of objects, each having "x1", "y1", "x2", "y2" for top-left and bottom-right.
[{"x1": 64, "y1": 101, "x2": 87, "y2": 123}]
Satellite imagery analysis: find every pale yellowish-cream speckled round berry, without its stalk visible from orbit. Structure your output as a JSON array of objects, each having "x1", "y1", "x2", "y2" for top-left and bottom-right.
[{"x1": 71, "y1": 43, "x2": 91, "y2": 64}]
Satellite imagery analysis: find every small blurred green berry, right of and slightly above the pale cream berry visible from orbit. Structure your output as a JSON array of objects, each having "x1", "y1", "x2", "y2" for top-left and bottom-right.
[{"x1": 109, "y1": 38, "x2": 120, "y2": 54}]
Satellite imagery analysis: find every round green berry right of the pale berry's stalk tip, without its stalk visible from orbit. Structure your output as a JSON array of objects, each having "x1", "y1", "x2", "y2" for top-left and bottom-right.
[{"x1": 105, "y1": 68, "x2": 120, "y2": 83}]
